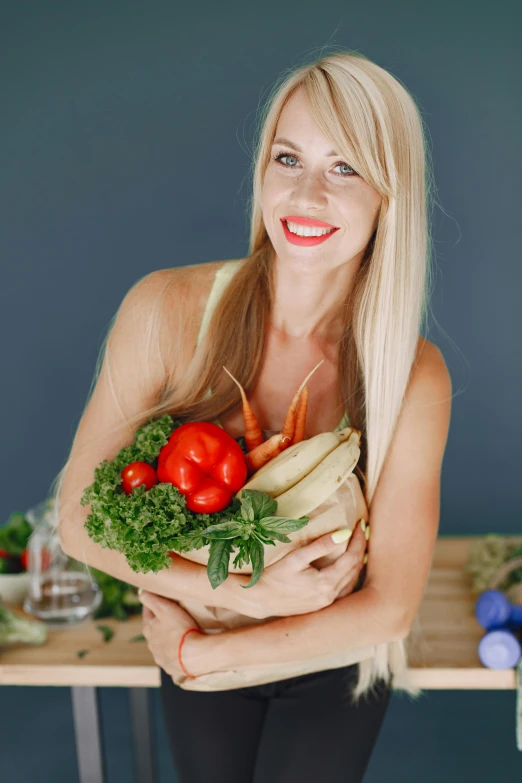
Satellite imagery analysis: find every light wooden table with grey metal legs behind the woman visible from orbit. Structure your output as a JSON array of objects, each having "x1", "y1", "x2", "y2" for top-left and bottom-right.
[{"x1": 0, "y1": 536, "x2": 522, "y2": 783}]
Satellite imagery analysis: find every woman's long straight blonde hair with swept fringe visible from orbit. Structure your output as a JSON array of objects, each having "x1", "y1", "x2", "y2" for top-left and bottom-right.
[{"x1": 49, "y1": 51, "x2": 433, "y2": 698}]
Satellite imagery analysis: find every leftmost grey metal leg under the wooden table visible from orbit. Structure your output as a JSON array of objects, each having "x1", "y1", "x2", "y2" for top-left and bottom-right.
[{"x1": 71, "y1": 686, "x2": 105, "y2": 783}]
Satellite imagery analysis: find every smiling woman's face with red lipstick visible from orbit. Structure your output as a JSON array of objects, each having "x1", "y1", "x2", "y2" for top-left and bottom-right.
[{"x1": 262, "y1": 90, "x2": 382, "y2": 272}]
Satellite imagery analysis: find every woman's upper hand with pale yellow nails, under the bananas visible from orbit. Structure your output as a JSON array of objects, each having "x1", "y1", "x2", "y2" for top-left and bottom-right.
[{"x1": 252, "y1": 522, "x2": 366, "y2": 619}]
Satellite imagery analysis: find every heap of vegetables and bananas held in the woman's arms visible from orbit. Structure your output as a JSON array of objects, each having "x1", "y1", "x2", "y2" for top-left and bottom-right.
[{"x1": 81, "y1": 362, "x2": 360, "y2": 589}]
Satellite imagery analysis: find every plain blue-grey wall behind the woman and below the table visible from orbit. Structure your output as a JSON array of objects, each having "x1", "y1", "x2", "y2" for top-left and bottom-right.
[{"x1": 0, "y1": 0, "x2": 522, "y2": 783}]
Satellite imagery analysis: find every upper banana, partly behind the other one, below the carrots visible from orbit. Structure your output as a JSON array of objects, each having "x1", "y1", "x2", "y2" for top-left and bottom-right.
[{"x1": 236, "y1": 427, "x2": 354, "y2": 497}]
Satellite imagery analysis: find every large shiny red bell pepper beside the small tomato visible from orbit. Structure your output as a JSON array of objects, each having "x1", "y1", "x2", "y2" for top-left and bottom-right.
[{"x1": 157, "y1": 421, "x2": 248, "y2": 514}]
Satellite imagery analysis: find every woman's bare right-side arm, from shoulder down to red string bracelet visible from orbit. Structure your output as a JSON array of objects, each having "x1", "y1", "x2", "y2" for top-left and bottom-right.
[{"x1": 183, "y1": 343, "x2": 451, "y2": 675}]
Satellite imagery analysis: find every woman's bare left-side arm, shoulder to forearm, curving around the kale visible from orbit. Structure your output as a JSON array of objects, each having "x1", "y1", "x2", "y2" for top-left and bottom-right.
[{"x1": 59, "y1": 269, "x2": 259, "y2": 617}]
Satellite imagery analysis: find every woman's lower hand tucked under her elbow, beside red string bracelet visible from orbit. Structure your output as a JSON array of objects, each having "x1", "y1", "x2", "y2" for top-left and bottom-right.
[{"x1": 140, "y1": 590, "x2": 210, "y2": 681}]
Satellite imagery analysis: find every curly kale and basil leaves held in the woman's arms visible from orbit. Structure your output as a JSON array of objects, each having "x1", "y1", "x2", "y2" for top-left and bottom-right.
[{"x1": 80, "y1": 414, "x2": 309, "y2": 597}]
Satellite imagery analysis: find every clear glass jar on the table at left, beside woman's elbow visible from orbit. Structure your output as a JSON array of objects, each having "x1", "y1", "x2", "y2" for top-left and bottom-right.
[{"x1": 23, "y1": 498, "x2": 102, "y2": 628}]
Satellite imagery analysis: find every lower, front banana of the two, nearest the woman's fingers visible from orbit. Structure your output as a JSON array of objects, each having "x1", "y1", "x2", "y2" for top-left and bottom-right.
[{"x1": 275, "y1": 431, "x2": 361, "y2": 519}]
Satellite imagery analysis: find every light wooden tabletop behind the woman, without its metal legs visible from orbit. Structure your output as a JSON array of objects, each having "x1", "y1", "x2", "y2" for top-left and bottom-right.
[{"x1": 0, "y1": 536, "x2": 522, "y2": 689}]
